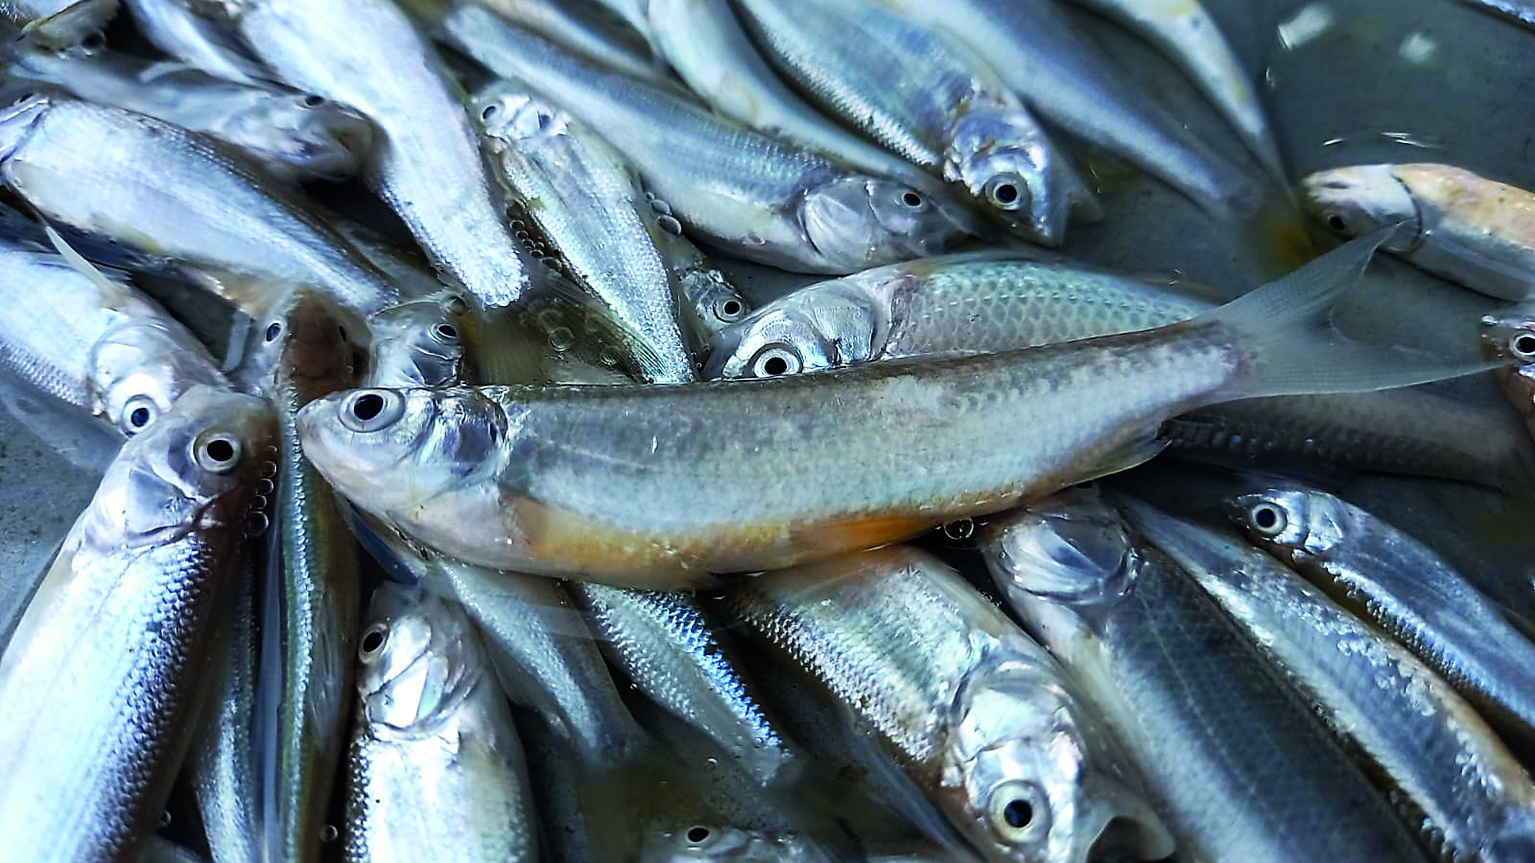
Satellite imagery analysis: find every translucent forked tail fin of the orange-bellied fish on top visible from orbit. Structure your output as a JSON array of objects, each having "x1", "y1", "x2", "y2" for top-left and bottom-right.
[{"x1": 1191, "y1": 219, "x2": 1500, "y2": 399}]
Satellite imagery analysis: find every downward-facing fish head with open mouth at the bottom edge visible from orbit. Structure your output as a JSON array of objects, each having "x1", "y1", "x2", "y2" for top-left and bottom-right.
[{"x1": 939, "y1": 651, "x2": 1173, "y2": 863}]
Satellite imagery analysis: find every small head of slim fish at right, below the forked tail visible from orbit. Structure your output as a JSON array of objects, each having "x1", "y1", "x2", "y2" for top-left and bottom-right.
[{"x1": 1225, "y1": 487, "x2": 1352, "y2": 562}]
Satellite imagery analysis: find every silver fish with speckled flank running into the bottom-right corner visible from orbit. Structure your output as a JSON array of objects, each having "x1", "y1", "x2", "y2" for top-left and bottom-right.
[{"x1": 1125, "y1": 501, "x2": 1535, "y2": 863}]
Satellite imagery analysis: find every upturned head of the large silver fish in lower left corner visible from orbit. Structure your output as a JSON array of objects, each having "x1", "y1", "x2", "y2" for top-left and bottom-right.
[{"x1": 77, "y1": 385, "x2": 276, "y2": 545}]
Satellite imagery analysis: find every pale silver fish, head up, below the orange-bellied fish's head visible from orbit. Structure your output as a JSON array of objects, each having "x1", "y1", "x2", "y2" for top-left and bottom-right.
[{"x1": 342, "y1": 582, "x2": 537, "y2": 863}]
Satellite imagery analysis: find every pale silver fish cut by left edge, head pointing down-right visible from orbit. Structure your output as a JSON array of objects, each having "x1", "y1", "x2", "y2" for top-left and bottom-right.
[{"x1": 0, "y1": 243, "x2": 229, "y2": 436}]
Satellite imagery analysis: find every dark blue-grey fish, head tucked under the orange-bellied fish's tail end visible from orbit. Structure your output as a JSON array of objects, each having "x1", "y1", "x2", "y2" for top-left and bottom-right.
[{"x1": 981, "y1": 487, "x2": 1428, "y2": 863}]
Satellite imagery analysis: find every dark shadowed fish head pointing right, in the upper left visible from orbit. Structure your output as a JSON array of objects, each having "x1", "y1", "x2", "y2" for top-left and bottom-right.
[{"x1": 218, "y1": 94, "x2": 376, "y2": 180}]
